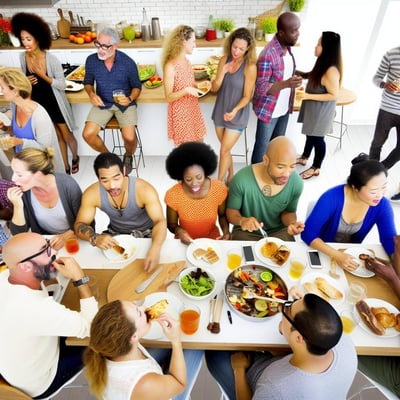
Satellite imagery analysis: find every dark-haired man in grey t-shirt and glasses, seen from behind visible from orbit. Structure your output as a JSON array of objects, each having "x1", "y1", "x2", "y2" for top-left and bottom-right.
[{"x1": 206, "y1": 294, "x2": 357, "y2": 400}]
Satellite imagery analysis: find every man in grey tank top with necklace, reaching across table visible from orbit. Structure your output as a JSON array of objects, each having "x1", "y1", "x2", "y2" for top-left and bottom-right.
[{"x1": 75, "y1": 153, "x2": 167, "y2": 272}]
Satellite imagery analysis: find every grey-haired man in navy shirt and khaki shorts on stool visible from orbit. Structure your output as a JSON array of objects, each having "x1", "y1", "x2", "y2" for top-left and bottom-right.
[{"x1": 82, "y1": 28, "x2": 142, "y2": 175}]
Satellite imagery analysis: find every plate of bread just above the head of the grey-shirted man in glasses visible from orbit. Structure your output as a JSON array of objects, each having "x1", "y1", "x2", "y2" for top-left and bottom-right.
[{"x1": 300, "y1": 272, "x2": 345, "y2": 306}]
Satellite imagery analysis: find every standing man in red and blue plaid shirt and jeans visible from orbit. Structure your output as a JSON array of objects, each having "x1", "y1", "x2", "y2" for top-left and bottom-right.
[{"x1": 251, "y1": 12, "x2": 303, "y2": 164}]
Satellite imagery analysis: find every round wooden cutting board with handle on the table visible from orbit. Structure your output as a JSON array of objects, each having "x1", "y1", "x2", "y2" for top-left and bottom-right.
[{"x1": 107, "y1": 259, "x2": 186, "y2": 302}]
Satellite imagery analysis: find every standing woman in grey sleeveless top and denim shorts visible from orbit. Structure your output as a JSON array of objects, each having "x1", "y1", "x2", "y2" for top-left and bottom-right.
[{"x1": 212, "y1": 28, "x2": 257, "y2": 182}]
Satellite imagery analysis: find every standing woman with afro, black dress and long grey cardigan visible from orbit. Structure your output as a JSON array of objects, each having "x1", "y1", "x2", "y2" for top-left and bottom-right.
[{"x1": 11, "y1": 13, "x2": 79, "y2": 174}]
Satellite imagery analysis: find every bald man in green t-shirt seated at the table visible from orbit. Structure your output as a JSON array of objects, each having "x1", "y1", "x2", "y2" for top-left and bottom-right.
[{"x1": 226, "y1": 136, "x2": 304, "y2": 241}]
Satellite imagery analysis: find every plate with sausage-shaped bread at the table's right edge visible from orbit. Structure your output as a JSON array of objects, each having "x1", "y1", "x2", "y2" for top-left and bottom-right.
[{"x1": 354, "y1": 298, "x2": 400, "y2": 338}]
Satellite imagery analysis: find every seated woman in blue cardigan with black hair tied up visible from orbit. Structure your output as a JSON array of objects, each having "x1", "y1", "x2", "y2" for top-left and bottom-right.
[{"x1": 301, "y1": 154, "x2": 396, "y2": 271}]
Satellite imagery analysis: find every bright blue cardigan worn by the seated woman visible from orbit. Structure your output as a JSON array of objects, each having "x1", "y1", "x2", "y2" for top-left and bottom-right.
[{"x1": 301, "y1": 185, "x2": 396, "y2": 256}]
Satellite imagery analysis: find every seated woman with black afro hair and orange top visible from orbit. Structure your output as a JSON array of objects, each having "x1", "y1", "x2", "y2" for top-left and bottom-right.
[{"x1": 164, "y1": 142, "x2": 230, "y2": 244}]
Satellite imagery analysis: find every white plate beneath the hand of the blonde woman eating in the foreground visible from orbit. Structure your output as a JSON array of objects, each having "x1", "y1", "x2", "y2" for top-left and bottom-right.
[{"x1": 142, "y1": 292, "x2": 183, "y2": 340}]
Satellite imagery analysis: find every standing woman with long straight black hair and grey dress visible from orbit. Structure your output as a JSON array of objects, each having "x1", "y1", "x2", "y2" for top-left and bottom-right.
[{"x1": 296, "y1": 32, "x2": 343, "y2": 179}]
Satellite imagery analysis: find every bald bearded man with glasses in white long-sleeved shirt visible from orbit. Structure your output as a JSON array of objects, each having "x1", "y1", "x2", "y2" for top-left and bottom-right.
[{"x1": 0, "y1": 232, "x2": 98, "y2": 398}]
